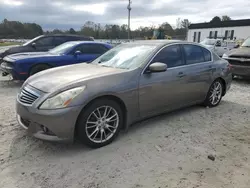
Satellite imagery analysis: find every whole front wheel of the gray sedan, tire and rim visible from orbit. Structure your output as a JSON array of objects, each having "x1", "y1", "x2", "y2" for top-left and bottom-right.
[{"x1": 76, "y1": 99, "x2": 123, "y2": 148}]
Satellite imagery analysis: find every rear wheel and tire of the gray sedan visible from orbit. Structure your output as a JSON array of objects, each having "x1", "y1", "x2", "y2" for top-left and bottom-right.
[{"x1": 204, "y1": 79, "x2": 224, "y2": 107}]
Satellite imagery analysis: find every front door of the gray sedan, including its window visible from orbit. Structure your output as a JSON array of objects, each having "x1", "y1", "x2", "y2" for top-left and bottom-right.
[{"x1": 139, "y1": 45, "x2": 188, "y2": 117}]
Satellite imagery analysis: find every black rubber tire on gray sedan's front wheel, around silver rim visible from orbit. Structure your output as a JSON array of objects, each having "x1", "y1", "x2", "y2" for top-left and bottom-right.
[{"x1": 76, "y1": 99, "x2": 124, "y2": 148}]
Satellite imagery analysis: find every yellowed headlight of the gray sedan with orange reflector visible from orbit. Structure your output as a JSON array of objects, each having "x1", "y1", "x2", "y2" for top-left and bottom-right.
[{"x1": 40, "y1": 87, "x2": 85, "y2": 109}]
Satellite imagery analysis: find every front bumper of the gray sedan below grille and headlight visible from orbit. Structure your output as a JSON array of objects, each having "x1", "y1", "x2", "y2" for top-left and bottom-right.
[{"x1": 16, "y1": 99, "x2": 81, "y2": 142}]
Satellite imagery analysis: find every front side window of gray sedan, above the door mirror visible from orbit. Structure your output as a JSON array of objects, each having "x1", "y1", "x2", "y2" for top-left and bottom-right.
[{"x1": 152, "y1": 45, "x2": 184, "y2": 68}]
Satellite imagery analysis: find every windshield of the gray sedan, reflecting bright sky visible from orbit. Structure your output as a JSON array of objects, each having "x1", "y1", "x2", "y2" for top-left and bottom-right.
[{"x1": 92, "y1": 44, "x2": 157, "y2": 69}]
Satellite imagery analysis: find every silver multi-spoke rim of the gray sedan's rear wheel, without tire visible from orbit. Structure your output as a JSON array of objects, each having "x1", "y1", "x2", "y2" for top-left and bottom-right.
[{"x1": 209, "y1": 81, "x2": 222, "y2": 105}]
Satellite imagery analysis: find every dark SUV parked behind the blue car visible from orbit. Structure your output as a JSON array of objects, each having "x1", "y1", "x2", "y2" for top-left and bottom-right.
[{"x1": 0, "y1": 34, "x2": 94, "y2": 64}]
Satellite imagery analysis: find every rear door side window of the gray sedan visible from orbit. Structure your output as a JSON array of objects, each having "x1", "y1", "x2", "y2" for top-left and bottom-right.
[{"x1": 183, "y1": 44, "x2": 205, "y2": 65}]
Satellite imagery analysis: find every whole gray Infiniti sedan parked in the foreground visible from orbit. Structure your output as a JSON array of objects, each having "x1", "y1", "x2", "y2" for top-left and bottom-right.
[{"x1": 16, "y1": 41, "x2": 232, "y2": 148}]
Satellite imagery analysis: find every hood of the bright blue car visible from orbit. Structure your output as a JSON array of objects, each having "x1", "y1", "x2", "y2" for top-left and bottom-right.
[{"x1": 8, "y1": 52, "x2": 59, "y2": 61}]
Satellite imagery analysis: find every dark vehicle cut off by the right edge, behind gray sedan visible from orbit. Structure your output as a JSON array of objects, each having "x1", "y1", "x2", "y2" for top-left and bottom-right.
[{"x1": 222, "y1": 38, "x2": 250, "y2": 77}]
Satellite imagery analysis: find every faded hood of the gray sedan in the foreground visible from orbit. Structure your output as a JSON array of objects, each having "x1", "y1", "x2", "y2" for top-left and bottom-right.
[{"x1": 24, "y1": 63, "x2": 127, "y2": 92}]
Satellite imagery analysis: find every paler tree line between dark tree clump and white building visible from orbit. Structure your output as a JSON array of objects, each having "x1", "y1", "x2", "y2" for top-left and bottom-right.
[{"x1": 45, "y1": 19, "x2": 190, "y2": 39}]
